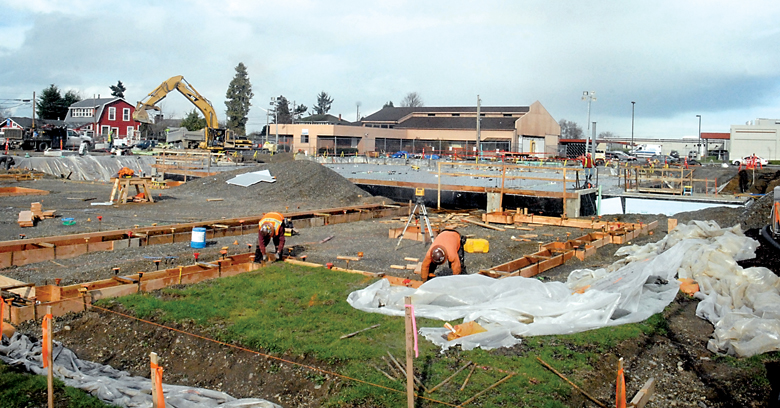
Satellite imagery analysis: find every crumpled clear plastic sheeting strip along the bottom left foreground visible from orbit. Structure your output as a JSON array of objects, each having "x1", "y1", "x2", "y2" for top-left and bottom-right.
[{"x1": 0, "y1": 333, "x2": 281, "y2": 408}]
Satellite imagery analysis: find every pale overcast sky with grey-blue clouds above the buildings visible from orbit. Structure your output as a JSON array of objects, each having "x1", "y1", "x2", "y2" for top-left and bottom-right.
[{"x1": 0, "y1": 0, "x2": 780, "y2": 138}]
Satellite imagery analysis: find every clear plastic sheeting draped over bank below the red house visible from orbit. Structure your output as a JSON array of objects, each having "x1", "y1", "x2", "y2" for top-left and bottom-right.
[{"x1": 14, "y1": 155, "x2": 155, "y2": 181}]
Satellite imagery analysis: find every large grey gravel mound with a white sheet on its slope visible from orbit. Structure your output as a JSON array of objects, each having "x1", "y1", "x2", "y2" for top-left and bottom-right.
[{"x1": 175, "y1": 160, "x2": 378, "y2": 209}]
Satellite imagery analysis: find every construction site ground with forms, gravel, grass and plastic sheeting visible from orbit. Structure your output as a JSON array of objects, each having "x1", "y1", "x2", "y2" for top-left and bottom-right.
[{"x1": 0, "y1": 152, "x2": 780, "y2": 407}]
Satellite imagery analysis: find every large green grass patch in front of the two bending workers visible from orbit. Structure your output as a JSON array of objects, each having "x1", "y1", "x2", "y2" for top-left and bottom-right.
[{"x1": 105, "y1": 264, "x2": 666, "y2": 407}]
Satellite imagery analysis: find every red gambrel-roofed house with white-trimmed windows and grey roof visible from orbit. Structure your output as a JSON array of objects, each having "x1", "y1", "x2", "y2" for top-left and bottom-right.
[{"x1": 64, "y1": 97, "x2": 140, "y2": 139}]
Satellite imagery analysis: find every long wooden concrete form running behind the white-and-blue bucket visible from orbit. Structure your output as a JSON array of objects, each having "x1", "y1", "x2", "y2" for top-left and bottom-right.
[{"x1": 0, "y1": 204, "x2": 407, "y2": 268}]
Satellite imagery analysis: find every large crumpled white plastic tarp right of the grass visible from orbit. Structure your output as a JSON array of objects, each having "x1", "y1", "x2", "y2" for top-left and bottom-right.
[{"x1": 347, "y1": 221, "x2": 780, "y2": 355}]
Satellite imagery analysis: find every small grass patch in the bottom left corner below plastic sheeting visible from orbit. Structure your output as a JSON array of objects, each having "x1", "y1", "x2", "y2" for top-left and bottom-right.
[{"x1": 0, "y1": 364, "x2": 112, "y2": 408}]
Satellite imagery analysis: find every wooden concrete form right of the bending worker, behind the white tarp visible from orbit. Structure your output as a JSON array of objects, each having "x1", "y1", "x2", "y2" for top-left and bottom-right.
[{"x1": 479, "y1": 221, "x2": 658, "y2": 279}]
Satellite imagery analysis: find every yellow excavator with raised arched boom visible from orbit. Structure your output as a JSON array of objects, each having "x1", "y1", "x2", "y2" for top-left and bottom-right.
[{"x1": 133, "y1": 75, "x2": 252, "y2": 150}]
